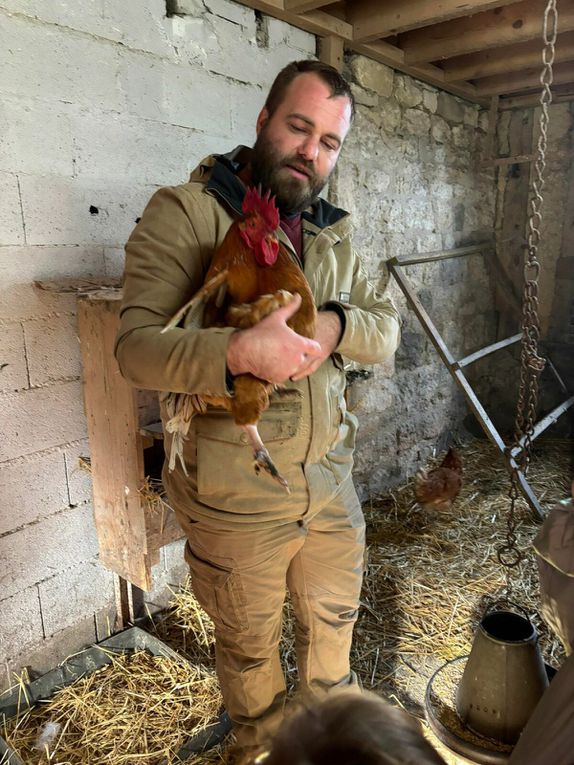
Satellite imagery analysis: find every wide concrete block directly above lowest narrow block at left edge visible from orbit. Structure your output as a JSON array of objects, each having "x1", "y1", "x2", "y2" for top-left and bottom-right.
[{"x1": 0, "y1": 505, "x2": 98, "y2": 597}]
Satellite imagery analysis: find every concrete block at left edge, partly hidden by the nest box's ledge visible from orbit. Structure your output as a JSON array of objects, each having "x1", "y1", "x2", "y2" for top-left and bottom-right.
[{"x1": 0, "y1": 247, "x2": 105, "y2": 321}]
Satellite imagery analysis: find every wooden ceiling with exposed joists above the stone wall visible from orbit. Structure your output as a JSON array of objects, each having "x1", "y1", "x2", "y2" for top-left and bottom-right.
[{"x1": 239, "y1": 0, "x2": 574, "y2": 108}]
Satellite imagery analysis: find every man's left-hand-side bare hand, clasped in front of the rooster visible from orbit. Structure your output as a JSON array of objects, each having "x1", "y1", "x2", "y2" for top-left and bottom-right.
[{"x1": 227, "y1": 294, "x2": 324, "y2": 383}]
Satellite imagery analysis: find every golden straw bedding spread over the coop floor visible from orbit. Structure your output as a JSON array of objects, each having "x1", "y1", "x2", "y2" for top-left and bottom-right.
[{"x1": 3, "y1": 440, "x2": 572, "y2": 765}]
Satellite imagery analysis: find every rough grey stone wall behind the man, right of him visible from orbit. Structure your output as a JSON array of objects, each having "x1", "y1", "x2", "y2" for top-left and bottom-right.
[{"x1": 338, "y1": 56, "x2": 495, "y2": 498}]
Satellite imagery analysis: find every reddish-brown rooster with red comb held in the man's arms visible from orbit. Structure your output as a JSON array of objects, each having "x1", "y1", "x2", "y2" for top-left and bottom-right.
[{"x1": 162, "y1": 188, "x2": 317, "y2": 492}]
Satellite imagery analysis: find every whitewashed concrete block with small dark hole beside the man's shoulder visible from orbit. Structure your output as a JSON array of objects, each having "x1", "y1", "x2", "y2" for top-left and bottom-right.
[{"x1": 21, "y1": 176, "x2": 156, "y2": 246}]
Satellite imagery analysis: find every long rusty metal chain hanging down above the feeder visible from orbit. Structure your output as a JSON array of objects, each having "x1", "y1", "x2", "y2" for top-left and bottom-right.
[{"x1": 497, "y1": 0, "x2": 558, "y2": 572}]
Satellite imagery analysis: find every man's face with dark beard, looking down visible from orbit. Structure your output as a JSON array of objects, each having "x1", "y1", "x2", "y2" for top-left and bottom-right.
[{"x1": 251, "y1": 73, "x2": 351, "y2": 213}]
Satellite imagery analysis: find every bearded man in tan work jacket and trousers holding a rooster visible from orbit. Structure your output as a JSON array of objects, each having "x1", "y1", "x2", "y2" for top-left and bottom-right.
[{"x1": 116, "y1": 61, "x2": 399, "y2": 763}]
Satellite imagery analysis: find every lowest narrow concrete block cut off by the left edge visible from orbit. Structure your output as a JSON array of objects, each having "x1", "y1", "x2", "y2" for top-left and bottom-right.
[{"x1": 0, "y1": 587, "x2": 43, "y2": 659}]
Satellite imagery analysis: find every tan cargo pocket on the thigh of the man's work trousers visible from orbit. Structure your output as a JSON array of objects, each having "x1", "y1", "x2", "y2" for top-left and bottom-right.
[{"x1": 185, "y1": 545, "x2": 248, "y2": 632}]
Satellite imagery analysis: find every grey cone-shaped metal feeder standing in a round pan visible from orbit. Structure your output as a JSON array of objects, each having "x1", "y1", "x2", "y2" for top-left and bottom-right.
[{"x1": 456, "y1": 610, "x2": 548, "y2": 744}]
